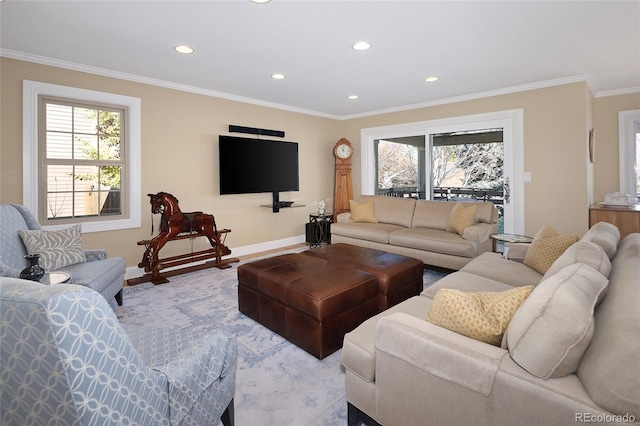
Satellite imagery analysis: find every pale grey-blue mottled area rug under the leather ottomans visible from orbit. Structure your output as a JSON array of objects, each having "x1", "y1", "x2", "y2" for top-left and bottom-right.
[{"x1": 116, "y1": 255, "x2": 445, "y2": 426}]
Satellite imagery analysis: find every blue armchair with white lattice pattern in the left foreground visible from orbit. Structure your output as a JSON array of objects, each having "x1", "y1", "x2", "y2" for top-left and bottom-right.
[{"x1": 0, "y1": 278, "x2": 237, "y2": 426}]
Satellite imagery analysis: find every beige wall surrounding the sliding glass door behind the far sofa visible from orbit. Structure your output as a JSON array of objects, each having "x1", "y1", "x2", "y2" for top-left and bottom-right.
[{"x1": 343, "y1": 83, "x2": 591, "y2": 235}]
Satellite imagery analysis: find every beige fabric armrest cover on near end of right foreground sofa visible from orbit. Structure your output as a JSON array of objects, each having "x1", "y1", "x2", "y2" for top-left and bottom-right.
[{"x1": 376, "y1": 313, "x2": 507, "y2": 396}]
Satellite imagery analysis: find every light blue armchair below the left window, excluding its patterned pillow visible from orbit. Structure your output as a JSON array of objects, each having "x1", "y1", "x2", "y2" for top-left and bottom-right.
[{"x1": 0, "y1": 204, "x2": 125, "y2": 309}]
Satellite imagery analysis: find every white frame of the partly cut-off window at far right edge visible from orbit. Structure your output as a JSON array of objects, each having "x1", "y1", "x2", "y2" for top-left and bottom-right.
[{"x1": 618, "y1": 109, "x2": 640, "y2": 199}]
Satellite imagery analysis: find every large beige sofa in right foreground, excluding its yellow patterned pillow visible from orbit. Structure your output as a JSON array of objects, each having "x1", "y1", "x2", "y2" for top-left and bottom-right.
[{"x1": 342, "y1": 222, "x2": 640, "y2": 426}]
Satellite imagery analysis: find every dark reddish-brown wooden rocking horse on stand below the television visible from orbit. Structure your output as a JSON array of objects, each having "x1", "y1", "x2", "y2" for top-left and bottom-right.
[{"x1": 127, "y1": 192, "x2": 238, "y2": 285}]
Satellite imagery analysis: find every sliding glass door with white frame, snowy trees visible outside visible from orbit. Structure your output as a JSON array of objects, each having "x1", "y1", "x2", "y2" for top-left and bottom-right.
[{"x1": 362, "y1": 111, "x2": 524, "y2": 233}]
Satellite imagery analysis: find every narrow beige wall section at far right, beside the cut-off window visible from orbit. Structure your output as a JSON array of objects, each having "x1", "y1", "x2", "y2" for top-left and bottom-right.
[{"x1": 593, "y1": 93, "x2": 640, "y2": 201}]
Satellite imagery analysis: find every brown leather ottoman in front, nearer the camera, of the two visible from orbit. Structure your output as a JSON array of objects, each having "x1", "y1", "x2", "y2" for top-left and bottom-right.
[{"x1": 238, "y1": 254, "x2": 378, "y2": 359}]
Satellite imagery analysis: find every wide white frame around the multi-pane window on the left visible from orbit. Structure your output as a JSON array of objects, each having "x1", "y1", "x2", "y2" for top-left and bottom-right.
[{"x1": 22, "y1": 80, "x2": 142, "y2": 232}]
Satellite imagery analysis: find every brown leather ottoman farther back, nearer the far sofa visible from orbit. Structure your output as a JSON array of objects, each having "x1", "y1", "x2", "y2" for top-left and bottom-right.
[{"x1": 301, "y1": 243, "x2": 424, "y2": 312}]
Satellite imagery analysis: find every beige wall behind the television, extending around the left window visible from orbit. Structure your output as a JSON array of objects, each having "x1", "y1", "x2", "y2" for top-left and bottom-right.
[{"x1": 0, "y1": 58, "x2": 340, "y2": 266}]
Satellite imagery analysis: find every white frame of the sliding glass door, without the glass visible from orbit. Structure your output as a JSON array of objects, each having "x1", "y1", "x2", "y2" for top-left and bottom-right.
[{"x1": 360, "y1": 109, "x2": 524, "y2": 234}]
